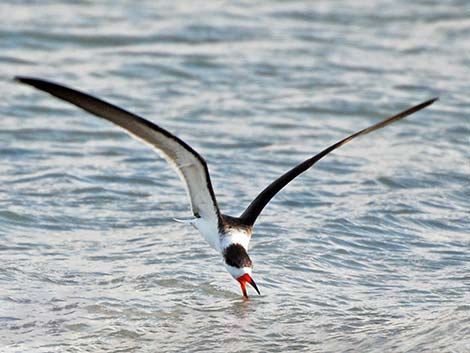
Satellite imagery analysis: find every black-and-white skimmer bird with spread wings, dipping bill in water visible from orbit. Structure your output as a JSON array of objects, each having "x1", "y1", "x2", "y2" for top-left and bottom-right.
[{"x1": 14, "y1": 76, "x2": 438, "y2": 299}]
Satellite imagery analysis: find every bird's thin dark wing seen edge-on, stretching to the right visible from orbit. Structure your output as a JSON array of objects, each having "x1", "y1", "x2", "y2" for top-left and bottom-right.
[{"x1": 240, "y1": 98, "x2": 438, "y2": 226}]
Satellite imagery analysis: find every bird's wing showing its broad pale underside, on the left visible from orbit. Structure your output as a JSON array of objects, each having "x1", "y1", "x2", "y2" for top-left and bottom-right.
[{"x1": 15, "y1": 77, "x2": 220, "y2": 224}]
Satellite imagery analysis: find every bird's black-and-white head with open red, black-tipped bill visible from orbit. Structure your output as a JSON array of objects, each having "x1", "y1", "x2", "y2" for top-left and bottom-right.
[{"x1": 223, "y1": 244, "x2": 261, "y2": 298}]
